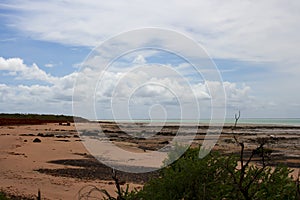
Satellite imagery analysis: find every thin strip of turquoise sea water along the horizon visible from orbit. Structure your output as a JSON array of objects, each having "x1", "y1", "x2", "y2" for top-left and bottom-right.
[{"x1": 108, "y1": 118, "x2": 300, "y2": 126}]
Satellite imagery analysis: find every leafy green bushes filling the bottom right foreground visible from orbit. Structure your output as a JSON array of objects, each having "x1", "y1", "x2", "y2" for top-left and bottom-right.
[{"x1": 126, "y1": 148, "x2": 297, "y2": 200}]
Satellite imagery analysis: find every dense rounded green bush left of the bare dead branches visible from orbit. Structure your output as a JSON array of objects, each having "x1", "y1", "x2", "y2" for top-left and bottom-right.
[{"x1": 132, "y1": 149, "x2": 236, "y2": 199}]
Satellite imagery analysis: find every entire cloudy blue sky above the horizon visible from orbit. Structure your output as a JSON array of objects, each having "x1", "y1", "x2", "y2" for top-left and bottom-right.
[{"x1": 0, "y1": 0, "x2": 300, "y2": 119}]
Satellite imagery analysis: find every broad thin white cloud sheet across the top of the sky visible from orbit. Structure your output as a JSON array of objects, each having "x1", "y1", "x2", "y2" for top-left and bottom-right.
[{"x1": 2, "y1": 0, "x2": 300, "y2": 64}]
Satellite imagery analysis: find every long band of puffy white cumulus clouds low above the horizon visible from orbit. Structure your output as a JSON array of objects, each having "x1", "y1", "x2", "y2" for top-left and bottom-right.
[{"x1": 0, "y1": 57, "x2": 255, "y2": 118}]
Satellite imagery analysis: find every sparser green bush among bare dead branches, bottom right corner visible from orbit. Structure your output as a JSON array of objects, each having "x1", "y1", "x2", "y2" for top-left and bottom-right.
[{"x1": 231, "y1": 165, "x2": 296, "y2": 200}]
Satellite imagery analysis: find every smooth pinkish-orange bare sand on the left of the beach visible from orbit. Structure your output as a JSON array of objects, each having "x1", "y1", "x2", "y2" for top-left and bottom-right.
[{"x1": 0, "y1": 124, "x2": 144, "y2": 199}]
